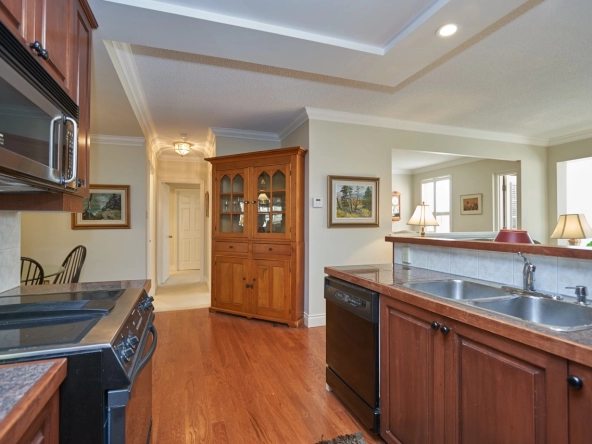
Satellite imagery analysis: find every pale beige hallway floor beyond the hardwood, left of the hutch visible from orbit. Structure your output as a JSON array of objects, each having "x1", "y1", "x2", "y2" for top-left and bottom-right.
[{"x1": 154, "y1": 270, "x2": 210, "y2": 312}]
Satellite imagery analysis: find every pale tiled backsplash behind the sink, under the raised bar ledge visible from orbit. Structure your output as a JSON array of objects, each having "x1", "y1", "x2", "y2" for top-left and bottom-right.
[{"x1": 395, "y1": 243, "x2": 592, "y2": 295}]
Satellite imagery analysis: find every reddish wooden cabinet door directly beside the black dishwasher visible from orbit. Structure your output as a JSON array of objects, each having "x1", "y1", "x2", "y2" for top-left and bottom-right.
[{"x1": 380, "y1": 297, "x2": 444, "y2": 444}]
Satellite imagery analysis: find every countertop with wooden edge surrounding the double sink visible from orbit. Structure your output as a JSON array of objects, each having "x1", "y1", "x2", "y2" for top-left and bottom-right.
[{"x1": 325, "y1": 264, "x2": 592, "y2": 366}]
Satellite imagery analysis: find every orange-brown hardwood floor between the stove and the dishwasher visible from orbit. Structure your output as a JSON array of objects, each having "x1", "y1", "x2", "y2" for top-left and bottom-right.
[{"x1": 152, "y1": 309, "x2": 383, "y2": 444}]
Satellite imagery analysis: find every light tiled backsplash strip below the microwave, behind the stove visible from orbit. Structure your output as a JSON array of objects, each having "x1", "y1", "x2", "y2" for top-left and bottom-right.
[{"x1": 0, "y1": 211, "x2": 21, "y2": 292}]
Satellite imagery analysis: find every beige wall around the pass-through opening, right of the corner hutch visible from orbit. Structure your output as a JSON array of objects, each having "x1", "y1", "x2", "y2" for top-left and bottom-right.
[{"x1": 305, "y1": 120, "x2": 547, "y2": 321}]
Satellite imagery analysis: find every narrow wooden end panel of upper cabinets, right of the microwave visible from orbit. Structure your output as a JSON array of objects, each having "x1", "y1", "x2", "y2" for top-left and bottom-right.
[{"x1": 70, "y1": 2, "x2": 92, "y2": 197}]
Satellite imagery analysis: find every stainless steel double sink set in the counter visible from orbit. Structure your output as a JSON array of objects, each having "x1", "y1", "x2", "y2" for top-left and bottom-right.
[{"x1": 403, "y1": 279, "x2": 592, "y2": 331}]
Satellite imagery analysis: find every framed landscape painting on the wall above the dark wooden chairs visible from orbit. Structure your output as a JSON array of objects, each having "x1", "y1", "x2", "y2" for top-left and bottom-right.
[{"x1": 72, "y1": 185, "x2": 130, "y2": 230}]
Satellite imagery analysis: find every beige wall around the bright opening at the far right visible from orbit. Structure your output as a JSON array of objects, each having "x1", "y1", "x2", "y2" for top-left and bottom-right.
[{"x1": 547, "y1": 139, "x2": 592, "y2": 244}]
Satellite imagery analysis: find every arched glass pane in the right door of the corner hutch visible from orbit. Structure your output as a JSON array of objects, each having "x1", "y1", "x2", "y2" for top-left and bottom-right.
[{"x1": 257, "y1": 170, "x2": 286, "y2": 233}]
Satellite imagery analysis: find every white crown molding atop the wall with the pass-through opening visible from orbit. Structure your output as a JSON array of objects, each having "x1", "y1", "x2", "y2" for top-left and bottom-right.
[{"x1": 306, "y1": 107, "x2": 549, "y2": 146}]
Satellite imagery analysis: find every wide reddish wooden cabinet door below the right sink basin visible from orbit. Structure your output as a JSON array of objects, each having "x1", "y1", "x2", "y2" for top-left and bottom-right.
[{"x1": 445, "y1": 323, "x2": 568, "y2": 444}]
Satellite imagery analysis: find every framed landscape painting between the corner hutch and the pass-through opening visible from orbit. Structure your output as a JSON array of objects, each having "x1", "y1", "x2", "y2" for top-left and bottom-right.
[{"x1": 327, "y1": 176, "x2": 380, "y2": 228}]
